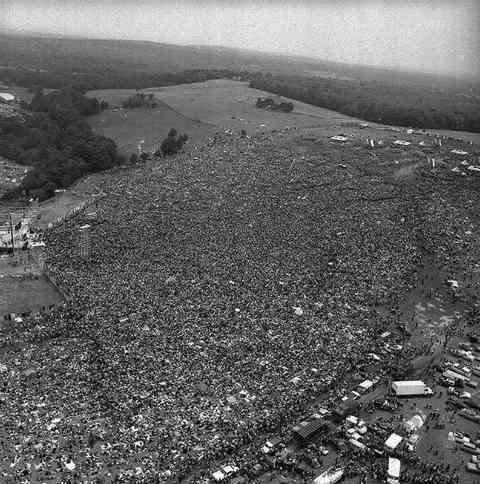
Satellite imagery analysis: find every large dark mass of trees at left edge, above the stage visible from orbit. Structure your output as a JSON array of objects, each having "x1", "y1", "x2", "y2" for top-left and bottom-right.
[{"x1": 0, "y1": 87, "x2": 125, "y2": 200}]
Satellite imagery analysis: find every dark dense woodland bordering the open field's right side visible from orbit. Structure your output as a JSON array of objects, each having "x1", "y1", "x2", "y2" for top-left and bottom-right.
[{"x1": 250, "y1": 74, "x2": 480, "y2": 133}]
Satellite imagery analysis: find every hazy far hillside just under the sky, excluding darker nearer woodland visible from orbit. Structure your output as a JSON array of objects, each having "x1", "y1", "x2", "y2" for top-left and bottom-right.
[{"x1": 0, "y1": 33, "x2": 471, "y2": 89}]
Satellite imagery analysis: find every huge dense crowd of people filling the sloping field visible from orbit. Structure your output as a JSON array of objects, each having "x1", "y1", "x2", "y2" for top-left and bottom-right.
[{"x1": 0, "y1": 126, "x2": 478, "y2": 482}]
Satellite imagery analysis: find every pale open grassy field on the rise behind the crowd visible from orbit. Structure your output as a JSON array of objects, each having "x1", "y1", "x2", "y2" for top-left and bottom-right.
[{"x1": 89, "y1": 79, "x2": 480, "y2": 153}]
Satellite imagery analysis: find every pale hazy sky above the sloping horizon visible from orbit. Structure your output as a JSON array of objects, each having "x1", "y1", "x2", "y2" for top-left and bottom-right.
[{"x1": 0, "y1": 0, "x2": 480, "y2": 75}]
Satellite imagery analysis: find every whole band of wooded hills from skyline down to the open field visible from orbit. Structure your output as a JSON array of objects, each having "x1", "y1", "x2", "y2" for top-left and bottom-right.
[{"x1": 0, "y1": 34, "x2": 480, "y2": 133}]
